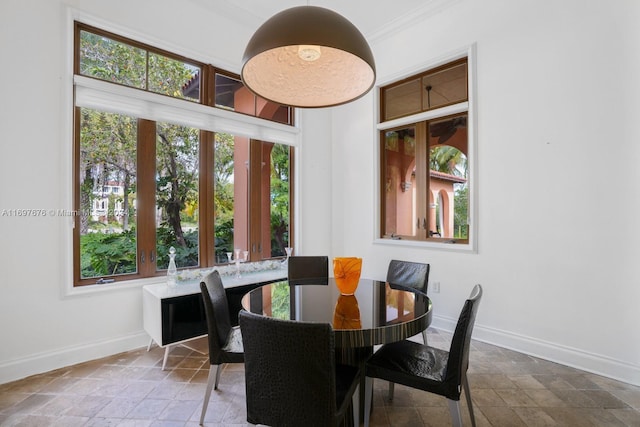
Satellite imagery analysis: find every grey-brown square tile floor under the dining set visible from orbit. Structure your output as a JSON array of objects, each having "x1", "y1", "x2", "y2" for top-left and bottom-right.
[{"x1": 0, "y1": 329, "x2": 640, "y2": 427}]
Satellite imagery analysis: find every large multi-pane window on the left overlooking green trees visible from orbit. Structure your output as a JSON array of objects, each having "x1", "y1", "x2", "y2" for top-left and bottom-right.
[{"x1": 74, "y1": 23, "x2": 293, "y2": 286}]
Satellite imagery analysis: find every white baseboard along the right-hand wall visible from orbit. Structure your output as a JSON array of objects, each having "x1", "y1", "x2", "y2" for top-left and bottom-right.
[{"x1": 431, "y1": 316, "x2": 640, "y2": 386}]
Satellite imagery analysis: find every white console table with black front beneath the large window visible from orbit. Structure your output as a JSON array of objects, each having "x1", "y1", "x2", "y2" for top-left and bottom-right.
[{"x1": 142, "y1": 269, "x2": 287, "y2": 370}]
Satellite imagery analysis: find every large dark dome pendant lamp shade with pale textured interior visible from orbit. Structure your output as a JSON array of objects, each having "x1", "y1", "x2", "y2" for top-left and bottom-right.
[{"x1": 241, "y1": 6, "x2": 376, "y2": 108}]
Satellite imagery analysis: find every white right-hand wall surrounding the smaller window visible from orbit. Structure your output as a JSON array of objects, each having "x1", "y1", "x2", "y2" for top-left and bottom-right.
[{"x1": 332, "y1": 0, "x2": 640, "y2": 384}]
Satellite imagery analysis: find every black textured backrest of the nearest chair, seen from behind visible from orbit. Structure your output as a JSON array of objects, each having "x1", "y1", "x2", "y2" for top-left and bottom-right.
[{"x1": 239, "y1": 310, "x2": 336, "y2": 427}]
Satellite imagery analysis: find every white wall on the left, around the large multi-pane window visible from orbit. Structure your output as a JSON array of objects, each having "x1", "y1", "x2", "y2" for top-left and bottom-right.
[{"x1": 0, "y1": 0, "x2": 264, "y2": 383}]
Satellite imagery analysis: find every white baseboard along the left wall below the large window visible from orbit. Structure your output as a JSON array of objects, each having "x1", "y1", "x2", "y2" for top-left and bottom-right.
[{"x1": 0, "y1": 331, "x2": 149, "y2": 384}]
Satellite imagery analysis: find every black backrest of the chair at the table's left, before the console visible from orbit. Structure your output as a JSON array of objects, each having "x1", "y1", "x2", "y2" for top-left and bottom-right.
[{"x1": 200, "y1": 270, "x2": 231, "y2": 364}]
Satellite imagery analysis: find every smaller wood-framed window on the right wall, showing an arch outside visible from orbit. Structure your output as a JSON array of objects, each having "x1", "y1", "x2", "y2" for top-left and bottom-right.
[{"x1": 379, "y1": 58, "x2": 470, "y2": 243}]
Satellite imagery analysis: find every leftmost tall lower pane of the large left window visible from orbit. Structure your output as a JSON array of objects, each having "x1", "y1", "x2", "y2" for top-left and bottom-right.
[{"x1": 76, "y1": 108, "x2": 138, "y2": 278}]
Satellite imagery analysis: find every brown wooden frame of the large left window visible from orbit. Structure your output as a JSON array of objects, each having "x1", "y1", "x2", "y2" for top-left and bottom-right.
[{"x1": 72, "y1": 22, "x2": 294, "y2": 287}]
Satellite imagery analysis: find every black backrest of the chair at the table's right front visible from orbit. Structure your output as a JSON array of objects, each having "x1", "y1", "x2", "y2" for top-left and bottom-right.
[{"x1": 445, "y1": 285, "x2": 482, "y2": 396}]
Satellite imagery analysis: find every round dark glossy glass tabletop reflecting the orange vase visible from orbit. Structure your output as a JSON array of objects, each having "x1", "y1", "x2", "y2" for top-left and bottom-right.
[{"x1": 242, "y1": 278, "x2": 431, "y2": 348}]
